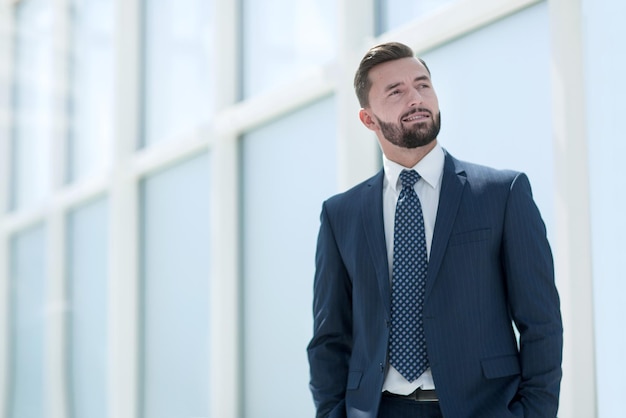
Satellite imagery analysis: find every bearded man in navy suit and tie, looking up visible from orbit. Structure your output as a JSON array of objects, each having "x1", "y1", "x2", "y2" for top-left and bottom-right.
[{"x1": 308, "y1": 43, "x2": 563, "y2": 418}]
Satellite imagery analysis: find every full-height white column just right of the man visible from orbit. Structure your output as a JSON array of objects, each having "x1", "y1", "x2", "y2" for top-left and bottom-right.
[{"x1": 550, "y1": 0, "x2": 596, "y2": 418}]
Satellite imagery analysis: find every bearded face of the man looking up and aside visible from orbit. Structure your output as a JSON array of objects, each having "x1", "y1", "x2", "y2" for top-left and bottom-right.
[{"x1": 364, "y1": 58, "x2": 441, "y2": 148}]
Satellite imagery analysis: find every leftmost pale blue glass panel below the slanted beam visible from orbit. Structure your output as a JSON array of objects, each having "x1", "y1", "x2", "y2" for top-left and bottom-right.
[{"x1": 9, "y1": 226, "x2": 46, "y2": 418}]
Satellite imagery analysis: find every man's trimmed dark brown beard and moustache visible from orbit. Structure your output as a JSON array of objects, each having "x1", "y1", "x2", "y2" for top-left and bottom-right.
[{"x1": 374, "y1": 109, "x2": 441, "y2": 148}]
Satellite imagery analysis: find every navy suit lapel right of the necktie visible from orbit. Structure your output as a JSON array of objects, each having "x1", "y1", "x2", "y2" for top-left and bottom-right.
[{"x1": 425, "y1": 152, "x2": 467, "y2": 298}]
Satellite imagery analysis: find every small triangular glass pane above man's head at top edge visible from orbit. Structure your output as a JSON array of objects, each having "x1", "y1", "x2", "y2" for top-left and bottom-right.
[{"x1": 376, "y1": 0, "x2": 458, "y2": 35}]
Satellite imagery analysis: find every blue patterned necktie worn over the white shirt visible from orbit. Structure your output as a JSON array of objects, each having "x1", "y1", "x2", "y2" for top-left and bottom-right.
[{"x1": 389, "y1": 170, "x2": 428, "y2": 382}]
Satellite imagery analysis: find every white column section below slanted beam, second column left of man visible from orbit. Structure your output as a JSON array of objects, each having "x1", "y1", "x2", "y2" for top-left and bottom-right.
[{"x1": 207, "y1": 136, "x2": 243, "y2": 418}]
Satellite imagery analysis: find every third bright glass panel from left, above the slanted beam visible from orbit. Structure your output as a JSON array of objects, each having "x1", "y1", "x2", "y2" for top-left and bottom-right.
[{"x1": 142, "y1": 0, "x2": 214, "y2": 146}]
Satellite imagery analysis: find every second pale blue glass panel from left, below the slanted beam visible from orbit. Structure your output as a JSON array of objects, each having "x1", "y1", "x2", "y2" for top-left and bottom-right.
[{"x1": 67, "y1": 199, "x2": 109, "y2": 418}]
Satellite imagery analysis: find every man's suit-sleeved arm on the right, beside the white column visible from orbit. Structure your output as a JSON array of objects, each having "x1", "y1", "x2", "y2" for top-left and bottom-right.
[{"x1": 502, "y1": 174, "x2": 563, "y2": 417}]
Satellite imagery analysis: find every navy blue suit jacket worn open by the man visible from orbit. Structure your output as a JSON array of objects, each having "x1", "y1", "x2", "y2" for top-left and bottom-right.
[{"x1": 307, "y1": 153, "x2": 563, "y2": 418}]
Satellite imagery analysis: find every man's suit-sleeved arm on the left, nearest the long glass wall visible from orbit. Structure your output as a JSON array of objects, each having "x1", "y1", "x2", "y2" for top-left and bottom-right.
[{"x1": 307, "y1": 204, "x2": 352, "y2": 418}]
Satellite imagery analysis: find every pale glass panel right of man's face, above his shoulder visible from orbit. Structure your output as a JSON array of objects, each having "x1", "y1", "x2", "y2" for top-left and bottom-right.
[{"x1": 422, "y1": 2, "x2": 555, "y2": 234}]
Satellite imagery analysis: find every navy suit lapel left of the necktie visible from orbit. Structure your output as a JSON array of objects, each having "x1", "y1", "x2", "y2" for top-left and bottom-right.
[{"x1": 355, "y1": 170, "x2": 391, "y2": 315}]
